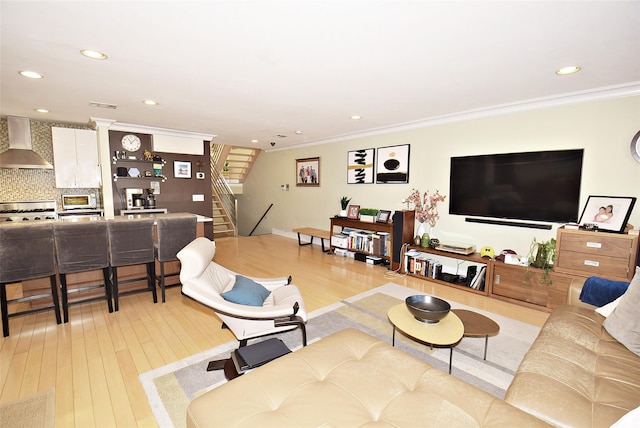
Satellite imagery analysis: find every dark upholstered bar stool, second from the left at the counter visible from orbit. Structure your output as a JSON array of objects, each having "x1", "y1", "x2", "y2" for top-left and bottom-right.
[{"x1": 53, "y1": 219, "x2": 113, "y2": 322}]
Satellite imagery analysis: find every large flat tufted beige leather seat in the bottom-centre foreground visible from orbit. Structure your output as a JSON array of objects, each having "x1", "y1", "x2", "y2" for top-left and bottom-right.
[{"x1": 187, "y1": 329, "x2": 548, "y2": 428}]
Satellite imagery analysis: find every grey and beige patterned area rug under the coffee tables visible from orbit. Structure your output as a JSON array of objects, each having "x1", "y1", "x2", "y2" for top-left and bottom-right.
[{"x1": 140, "y1": 283, "x2": 540, "y2": 427}]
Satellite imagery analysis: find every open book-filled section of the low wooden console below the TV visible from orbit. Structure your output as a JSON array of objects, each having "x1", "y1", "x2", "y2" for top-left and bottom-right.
[{"x1": 402, "y1": 245, "x2": 493, "y2": 296}]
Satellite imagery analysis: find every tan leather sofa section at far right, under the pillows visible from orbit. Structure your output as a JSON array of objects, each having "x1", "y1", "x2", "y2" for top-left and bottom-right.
[{"x1": 505, "y1": 281, "x2": 640, "y2": 427}]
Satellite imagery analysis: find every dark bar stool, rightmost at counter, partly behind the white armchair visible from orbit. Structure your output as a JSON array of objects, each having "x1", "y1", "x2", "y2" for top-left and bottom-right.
[{"x1": 155, "y1": 213, "x2": 197, "y2": 303}]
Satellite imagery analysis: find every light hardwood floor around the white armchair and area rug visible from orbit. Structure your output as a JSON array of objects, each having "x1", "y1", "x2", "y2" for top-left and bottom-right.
[{"x1": 0, "y1": 235, "x2": 548, "y2": 428}]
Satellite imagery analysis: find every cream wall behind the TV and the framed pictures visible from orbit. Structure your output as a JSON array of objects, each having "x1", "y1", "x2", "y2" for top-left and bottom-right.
[{"x1": 239, "y1": 97, "x2": 640, "y2": 255}]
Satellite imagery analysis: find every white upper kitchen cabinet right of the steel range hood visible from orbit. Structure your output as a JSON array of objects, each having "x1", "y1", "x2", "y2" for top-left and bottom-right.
[{"x1": 51, "y1": 127, "x2": 100, "y2": 189}]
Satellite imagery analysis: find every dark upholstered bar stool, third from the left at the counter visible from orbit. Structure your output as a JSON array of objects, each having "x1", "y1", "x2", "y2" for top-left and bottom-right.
[{"x1": 107, "y1": 217, "x2": 158, "y2": 311}]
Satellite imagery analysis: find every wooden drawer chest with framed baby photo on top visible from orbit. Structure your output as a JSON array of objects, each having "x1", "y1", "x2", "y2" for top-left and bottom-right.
[{"x1": 554, "y1": 228, "x2": 638, "y2": 281}]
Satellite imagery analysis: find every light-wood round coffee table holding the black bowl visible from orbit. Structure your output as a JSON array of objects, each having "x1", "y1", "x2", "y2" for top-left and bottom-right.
[{"x1": 387, "y1": 302, "x2": 464, "y2": 374}]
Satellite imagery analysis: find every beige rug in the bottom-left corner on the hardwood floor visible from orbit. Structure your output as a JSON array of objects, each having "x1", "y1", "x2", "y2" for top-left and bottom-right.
[{"x1": 0, "y1": 388, "x2": 56, "y2": 428}]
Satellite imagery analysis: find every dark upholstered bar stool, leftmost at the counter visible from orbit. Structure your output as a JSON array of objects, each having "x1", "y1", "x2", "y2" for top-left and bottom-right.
[{"x1": 0, "y1": 221, "x2": 62, "y2": 337}]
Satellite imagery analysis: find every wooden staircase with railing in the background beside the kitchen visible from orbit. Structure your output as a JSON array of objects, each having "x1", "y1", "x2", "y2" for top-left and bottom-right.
[{"x1": 210, "y1": 142, "x2": 260, "y2": 237}]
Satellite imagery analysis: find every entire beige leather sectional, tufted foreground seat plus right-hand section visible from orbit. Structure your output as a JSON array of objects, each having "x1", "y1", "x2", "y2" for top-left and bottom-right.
[{"x1": 187, "y1": 276, "x2": 640, "y2": 428}]
